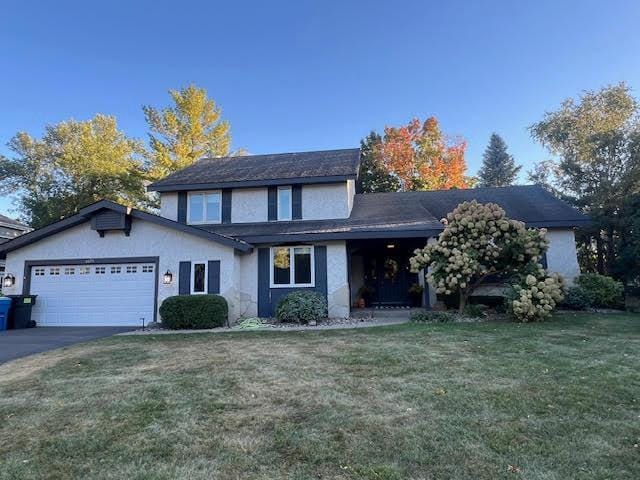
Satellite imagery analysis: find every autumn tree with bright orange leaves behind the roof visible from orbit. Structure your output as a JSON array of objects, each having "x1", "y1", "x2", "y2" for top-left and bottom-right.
[{"x1": 362, "y1": 117, "x2": 471, "y2": 192}]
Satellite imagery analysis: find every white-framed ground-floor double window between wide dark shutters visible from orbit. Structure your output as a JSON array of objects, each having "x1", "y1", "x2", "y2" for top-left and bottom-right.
[{"x1": 271, "y1": 246, "x2": 315, "y2": 288}]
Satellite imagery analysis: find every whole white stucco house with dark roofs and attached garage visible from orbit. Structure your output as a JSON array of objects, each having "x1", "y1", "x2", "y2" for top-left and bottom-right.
[{"x1": 0, "y1": 149, "x2": 588, "y2": 325}]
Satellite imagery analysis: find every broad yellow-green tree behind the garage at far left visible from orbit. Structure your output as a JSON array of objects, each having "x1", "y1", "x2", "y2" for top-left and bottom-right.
[{"x1": 0, "y1": 115, "x2": 149, "y2": 228}]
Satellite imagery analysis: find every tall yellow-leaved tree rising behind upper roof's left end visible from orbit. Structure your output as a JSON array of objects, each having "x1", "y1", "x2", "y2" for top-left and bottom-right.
[{"x1": 142, "y1": 85, "x2": 231, "y2": 179}]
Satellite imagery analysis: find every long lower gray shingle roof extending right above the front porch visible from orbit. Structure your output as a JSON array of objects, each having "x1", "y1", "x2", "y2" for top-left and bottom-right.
[{"x1": 202, "y1": 186, "x2": 589, "y2": 243}]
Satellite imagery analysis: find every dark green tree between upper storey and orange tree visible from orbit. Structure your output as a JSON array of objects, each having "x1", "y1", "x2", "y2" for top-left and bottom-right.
[{"x1": 357, "y1": 131, "x2": 400, "y2": 193}]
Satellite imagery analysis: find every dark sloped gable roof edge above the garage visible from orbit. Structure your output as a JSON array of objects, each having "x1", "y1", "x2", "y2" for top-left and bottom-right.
[{"x1": 0, "y1": 200, "x2": 252, "y2": 258}]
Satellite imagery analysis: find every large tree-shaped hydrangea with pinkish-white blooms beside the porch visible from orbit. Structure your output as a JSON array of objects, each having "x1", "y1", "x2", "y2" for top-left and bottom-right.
[{"x1": 410, "y1": 200, "x2": 549, "y2": 313}]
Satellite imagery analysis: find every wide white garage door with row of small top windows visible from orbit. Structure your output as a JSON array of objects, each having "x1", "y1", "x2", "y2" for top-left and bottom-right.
[{"x1": 30, "y1": 263, "x2": 156, "y2": 326}]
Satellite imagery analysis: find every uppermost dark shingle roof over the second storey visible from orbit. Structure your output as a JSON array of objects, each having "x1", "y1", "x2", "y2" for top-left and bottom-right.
[{"x1": 148, "y1": 148, "x2": 360, "y2": 192}]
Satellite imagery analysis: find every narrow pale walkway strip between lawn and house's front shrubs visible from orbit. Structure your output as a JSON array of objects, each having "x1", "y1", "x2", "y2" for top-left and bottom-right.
[{"x1": 119, "y1": 318, "x2": 409, "y2": 335}]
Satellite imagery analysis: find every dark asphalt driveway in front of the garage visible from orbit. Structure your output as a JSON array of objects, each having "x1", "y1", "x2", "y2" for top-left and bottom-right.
[{"x1": 0, "y1": 327, "x2": 135, "y2": 363}]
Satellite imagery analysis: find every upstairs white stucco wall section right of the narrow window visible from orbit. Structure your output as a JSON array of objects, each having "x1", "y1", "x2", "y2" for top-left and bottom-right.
[{"x1": 302, "y1": 182, "x2": 351, "y2": 220}]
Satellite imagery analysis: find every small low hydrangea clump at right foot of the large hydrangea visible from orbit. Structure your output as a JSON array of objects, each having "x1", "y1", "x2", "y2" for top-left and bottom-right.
[{"x1": 510, "y1": 267, "x2": 564, "y2": 322}]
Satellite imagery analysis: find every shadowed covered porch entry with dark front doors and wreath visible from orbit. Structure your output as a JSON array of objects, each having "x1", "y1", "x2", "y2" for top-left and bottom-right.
[{"x1": 347, "y1": 238, "x2": 428, "y2": 308}]
